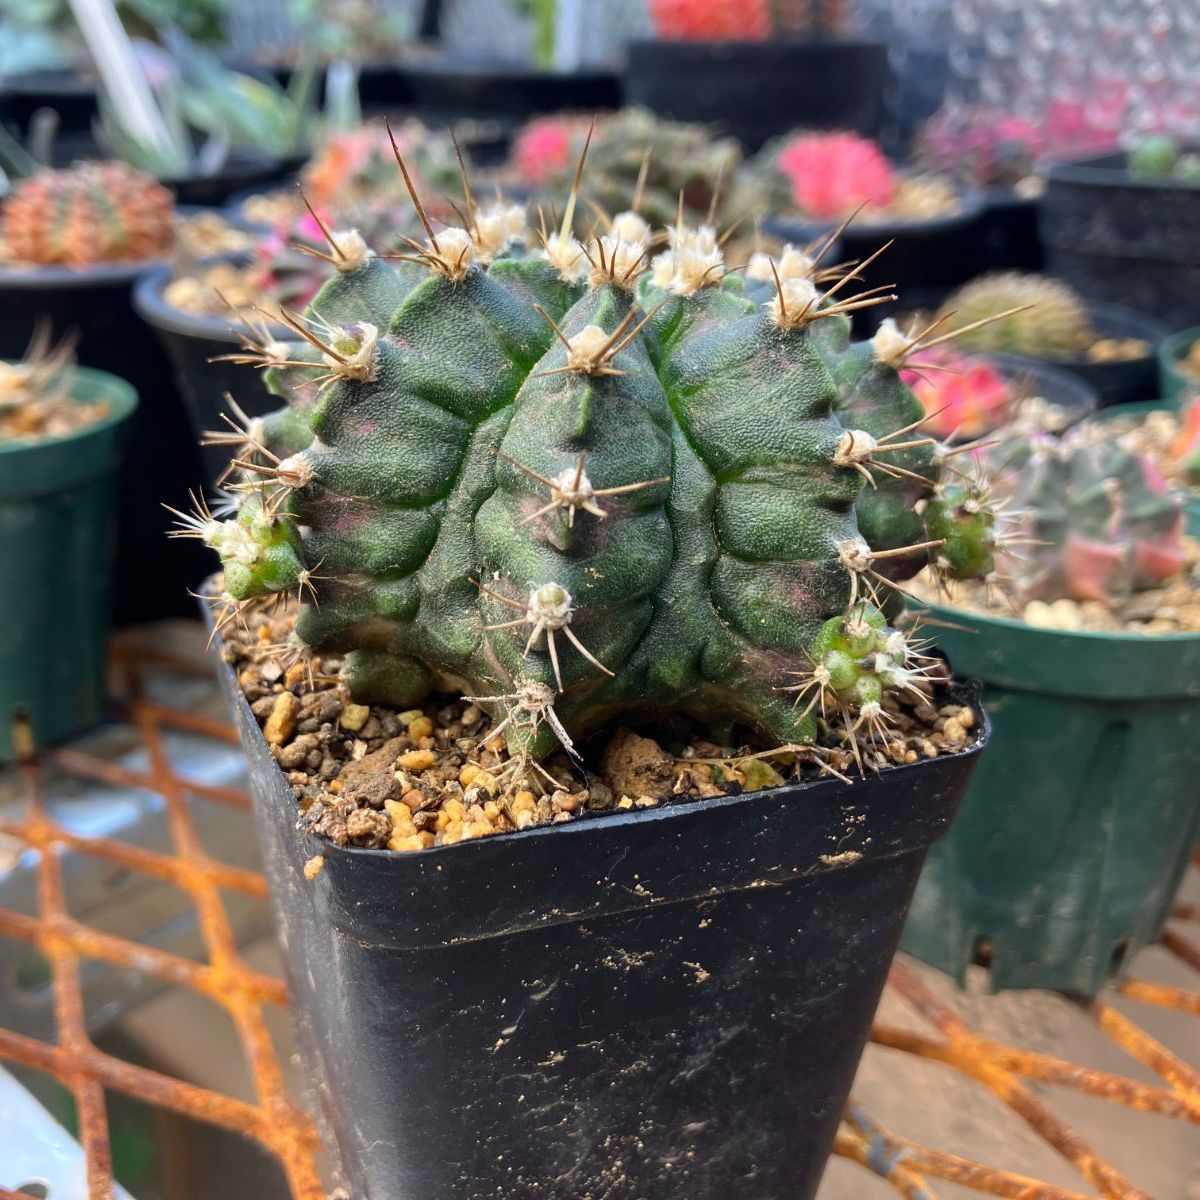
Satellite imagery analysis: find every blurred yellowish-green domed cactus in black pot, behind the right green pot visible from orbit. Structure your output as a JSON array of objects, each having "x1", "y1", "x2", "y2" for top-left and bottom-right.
[{"x1": 938, "y1": 271, "x2": 1096, "y2": 359}]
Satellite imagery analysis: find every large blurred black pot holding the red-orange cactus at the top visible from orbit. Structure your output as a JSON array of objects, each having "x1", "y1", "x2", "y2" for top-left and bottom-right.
[{"x1": 625, "y1": 38, "x2": 888, "y2": 150}]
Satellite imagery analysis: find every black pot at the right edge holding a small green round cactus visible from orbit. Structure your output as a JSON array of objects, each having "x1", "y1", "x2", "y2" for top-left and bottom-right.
[{"x1": 1042, "y1": 154, "x2": 1200, "y2": 329}]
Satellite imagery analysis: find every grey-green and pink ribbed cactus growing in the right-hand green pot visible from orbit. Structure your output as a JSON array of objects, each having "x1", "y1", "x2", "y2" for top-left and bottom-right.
[{"x1": 989, "y1": 426, "x2": 1187, "y2": 607}]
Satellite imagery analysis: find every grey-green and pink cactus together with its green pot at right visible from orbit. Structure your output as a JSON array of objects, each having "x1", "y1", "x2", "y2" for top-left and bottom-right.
[{"x1": 905, "y1": 406, "x2": 1200, "y2": 996}]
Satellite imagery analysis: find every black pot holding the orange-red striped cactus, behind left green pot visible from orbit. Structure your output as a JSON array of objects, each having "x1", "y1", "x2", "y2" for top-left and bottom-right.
[{"x1": 0, "y1": 263, "x2": 211, "y2": 624}]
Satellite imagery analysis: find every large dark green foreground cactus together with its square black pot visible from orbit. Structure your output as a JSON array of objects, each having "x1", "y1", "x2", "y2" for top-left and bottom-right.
[{"x1": 187, "y1": 136, "x2": 1006, "y2": 1200}]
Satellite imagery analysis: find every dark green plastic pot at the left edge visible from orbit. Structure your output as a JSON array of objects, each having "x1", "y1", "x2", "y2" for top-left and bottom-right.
[{"x1": 0, "y1": 367, "x2": 138, "y2": 762}]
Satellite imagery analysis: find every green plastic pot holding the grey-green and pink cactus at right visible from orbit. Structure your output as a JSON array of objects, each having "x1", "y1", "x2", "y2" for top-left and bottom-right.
[{"x1": 902, "y1": 605, "x2": 1200, "y2": 996}]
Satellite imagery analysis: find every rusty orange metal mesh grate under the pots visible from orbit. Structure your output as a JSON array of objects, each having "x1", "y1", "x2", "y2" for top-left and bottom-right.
[{"x1": 0, "y1": 640, "x2": 1200, "y2": 1200}]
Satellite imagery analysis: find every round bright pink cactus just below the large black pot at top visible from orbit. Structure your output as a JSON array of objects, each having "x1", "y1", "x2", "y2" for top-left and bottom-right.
[{"x1": 775, "y1": 133, "x2": 898, "y2": 221}]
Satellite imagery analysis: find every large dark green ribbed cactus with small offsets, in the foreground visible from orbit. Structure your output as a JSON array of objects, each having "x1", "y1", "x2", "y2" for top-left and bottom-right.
[{"x1": 181, "y1": 136, "x2": 1001, "y2": 757}]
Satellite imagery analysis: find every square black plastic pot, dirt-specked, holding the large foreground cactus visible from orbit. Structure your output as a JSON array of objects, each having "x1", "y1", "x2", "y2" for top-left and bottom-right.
[{"x1": 213, "y1": 633, "x2": 986, "y2": 1200}]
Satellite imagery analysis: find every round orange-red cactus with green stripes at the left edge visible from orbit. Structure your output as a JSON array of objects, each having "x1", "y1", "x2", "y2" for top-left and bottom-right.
[{"x1": 2, "y1": 162, "x2": 175, "y2": 266}]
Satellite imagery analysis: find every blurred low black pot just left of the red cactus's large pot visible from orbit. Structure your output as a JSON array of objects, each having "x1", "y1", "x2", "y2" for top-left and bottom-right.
[{"x1": 403, "y1": 54, "x2": 620, "y2": 125}]
